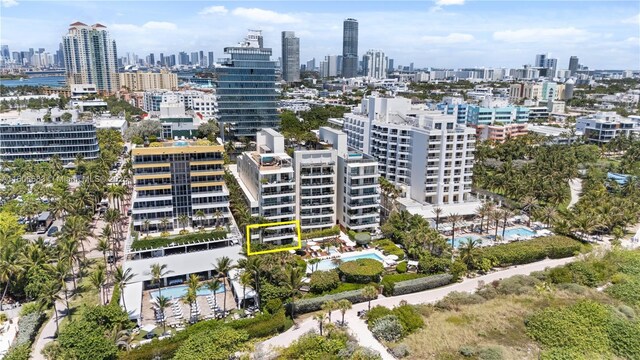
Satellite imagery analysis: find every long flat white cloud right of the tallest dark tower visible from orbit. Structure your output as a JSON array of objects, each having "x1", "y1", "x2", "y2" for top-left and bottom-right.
[{"x1": 493, "y1": 27, "x2": 594, "y2": 43}]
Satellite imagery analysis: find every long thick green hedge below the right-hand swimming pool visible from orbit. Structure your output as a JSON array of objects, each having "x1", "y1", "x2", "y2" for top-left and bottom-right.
[{"x1": 478, "y1": 236, "x2": 583, "y2": 266}]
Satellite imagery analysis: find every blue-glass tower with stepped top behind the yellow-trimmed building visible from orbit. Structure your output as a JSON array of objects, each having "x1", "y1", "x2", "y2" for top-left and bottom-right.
[{"x1": 216, "y1": 30, "x2": 280, "y2": 139}]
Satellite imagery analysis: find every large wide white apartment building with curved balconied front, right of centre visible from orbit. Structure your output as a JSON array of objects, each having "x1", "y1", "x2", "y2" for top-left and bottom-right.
[{"x1": 344, "y1": 97, "x2": 476, "y2": 206}]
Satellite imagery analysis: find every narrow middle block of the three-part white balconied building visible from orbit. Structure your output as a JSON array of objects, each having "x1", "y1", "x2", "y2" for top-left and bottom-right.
[{"x1": 293, "y1": 149, "x2": 337, "y2": 231}]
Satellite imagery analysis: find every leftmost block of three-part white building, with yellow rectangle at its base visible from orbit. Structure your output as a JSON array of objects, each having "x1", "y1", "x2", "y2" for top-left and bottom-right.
[{"x1": 232, "y1": 129, "x2": 298, "y2": 245}]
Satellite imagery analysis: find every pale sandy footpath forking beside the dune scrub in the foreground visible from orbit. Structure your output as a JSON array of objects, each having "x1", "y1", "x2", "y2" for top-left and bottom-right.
[{"x1": 256, "y1": 258, "x2": 576, "y2": 360}]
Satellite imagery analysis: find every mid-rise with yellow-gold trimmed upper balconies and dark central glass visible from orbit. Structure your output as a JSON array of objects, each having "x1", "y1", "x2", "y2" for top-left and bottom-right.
[{"x1": 131, "y1": 140, "x2": 231, "y2": 232}]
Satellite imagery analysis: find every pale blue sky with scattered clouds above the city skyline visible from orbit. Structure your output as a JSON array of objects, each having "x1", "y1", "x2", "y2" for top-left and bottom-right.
[{"x1": 0, "y1": 0, "x2": 640, "y2": 69}]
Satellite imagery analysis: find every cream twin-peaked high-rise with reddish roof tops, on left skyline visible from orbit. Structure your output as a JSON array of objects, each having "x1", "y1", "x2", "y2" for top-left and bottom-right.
[{"x1": 62, "y1": 22, "x2": 118, "y2": 92}]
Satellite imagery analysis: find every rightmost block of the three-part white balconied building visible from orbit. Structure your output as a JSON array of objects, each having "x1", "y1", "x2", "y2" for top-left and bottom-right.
[{"x1": 319, "y1": 127, "x2": 380, "y2": 232}]
